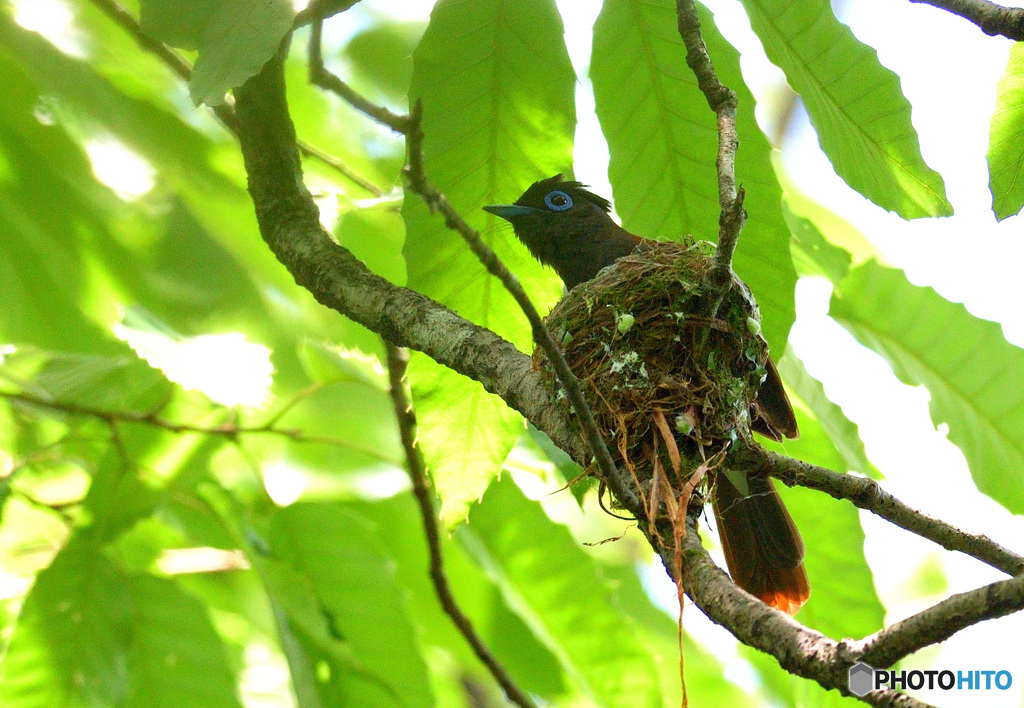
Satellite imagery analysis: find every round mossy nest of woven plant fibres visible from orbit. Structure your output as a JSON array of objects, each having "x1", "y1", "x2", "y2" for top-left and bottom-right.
[{"x1": 534, "y1": 242, "x2": 768, "y2": 488}]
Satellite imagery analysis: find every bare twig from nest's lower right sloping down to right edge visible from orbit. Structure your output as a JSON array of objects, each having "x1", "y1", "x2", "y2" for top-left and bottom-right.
[{"x1": 745, "y1": 446, "x2": 1024, "y2": 576}]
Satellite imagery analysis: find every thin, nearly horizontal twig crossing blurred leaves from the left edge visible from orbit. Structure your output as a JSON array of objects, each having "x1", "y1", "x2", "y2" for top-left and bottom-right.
[{"x1": 0, "y1": 391, "x2": 398, "y2": 465}]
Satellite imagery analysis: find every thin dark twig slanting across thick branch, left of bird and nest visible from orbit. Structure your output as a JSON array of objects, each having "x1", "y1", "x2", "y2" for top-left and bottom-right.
[{"x1": 407, "y1": 101, "x2": 642, "y2": 517}]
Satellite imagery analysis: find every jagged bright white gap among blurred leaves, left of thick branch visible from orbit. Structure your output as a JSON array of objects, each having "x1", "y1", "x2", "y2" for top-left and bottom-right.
[{"x1": 114, "y1": 324, "x2": 273, "y2": 408}]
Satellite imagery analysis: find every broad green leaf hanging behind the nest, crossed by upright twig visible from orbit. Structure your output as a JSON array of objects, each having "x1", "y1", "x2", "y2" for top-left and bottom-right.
[{"x1": 591, "y1": 0, "x2": 797, "y2": 352}]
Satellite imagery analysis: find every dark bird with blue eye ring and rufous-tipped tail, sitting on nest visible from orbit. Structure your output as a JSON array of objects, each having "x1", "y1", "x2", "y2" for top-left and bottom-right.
[{"x1": 483, "y1": 174, "x2": 810, "y2": 615}]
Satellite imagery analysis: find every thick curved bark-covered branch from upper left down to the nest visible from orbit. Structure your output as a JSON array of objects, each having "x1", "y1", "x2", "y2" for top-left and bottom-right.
[{"x1": 236, "y1": 45, "x2": 606, "y2": 500}]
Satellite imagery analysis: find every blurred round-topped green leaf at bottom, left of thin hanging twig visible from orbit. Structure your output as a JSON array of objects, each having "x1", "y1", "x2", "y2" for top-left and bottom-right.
[{"x1": 267, "y1": 503, "x2": 433, "y2": 708}]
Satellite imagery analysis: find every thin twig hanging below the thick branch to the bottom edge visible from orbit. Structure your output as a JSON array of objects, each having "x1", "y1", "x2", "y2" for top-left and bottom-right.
[{"x1": 384, "y1": 340, "x2": 536, "y2": 708}]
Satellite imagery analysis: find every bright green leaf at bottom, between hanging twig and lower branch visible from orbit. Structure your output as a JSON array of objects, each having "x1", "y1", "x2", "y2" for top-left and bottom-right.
[{"x1": 460, "y1": 477, "x2": 663, "y2": 708}]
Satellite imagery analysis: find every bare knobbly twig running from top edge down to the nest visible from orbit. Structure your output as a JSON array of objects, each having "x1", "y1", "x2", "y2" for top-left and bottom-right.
[{"x1": 676, "y1": 0, "x2": 746, "y2": 297}]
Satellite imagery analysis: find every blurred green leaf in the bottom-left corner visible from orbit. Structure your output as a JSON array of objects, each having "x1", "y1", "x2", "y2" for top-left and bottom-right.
[{"x1": 0, "y1": 537, "x2": 131, "y2": 708}]
